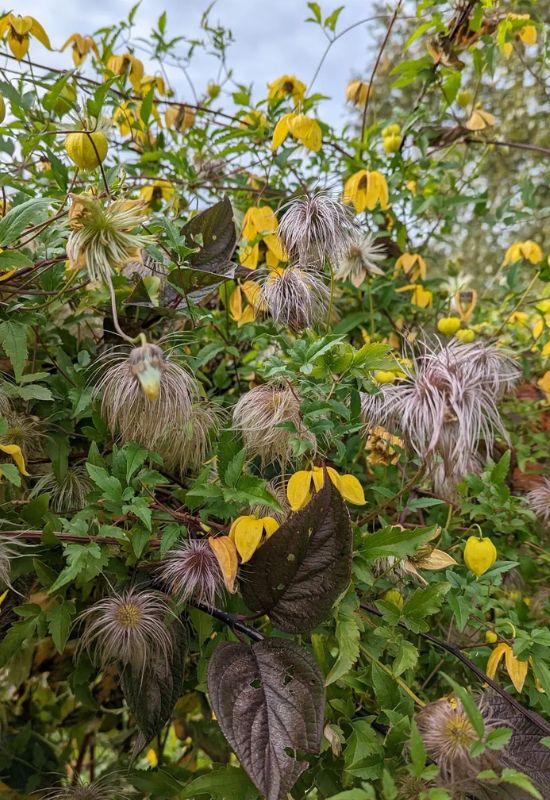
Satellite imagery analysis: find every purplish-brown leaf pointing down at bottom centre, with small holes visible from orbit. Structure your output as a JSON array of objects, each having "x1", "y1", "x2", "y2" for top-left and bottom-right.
[{"x1": 208, "y1": 639, "x2": 325, "y2": 800}]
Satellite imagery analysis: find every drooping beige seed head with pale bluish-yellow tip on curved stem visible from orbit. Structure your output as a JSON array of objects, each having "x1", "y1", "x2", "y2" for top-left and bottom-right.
[{"x1": 97, "y1": 344, "x2": 201, "y2": 452}]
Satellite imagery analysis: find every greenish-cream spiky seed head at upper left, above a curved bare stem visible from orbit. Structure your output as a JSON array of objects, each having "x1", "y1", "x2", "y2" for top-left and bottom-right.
[{"x1": 67, "y1": 194, "x2": 151, "y2": 281}]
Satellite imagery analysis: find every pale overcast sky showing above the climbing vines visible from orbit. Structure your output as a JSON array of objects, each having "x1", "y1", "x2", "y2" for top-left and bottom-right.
[{"x1": 14, "y1": 0, "x2": 381, "y2": 125}]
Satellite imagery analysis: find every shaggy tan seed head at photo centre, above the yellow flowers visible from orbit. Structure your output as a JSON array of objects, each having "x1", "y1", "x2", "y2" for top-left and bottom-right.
[{"x1": 233, "y1": 384, "x2": 315, "y2": 467}]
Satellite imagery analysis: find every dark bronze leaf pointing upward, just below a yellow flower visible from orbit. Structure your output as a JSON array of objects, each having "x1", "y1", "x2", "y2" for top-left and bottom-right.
[{"x1": 241, "y1": 473, "x2": 353, "y2": 633}]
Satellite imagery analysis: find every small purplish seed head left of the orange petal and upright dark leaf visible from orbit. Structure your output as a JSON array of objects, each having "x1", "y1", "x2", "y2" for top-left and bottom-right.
[{"x1": 159, "y1": 539, "x2": 223, "y2": 606}]
